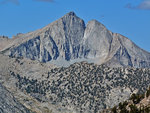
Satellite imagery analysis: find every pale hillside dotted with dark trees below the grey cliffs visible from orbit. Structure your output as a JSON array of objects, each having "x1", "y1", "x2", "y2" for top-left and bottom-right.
[{"x1": 0, "y1": 55, "x2": 150, "y2": 113}]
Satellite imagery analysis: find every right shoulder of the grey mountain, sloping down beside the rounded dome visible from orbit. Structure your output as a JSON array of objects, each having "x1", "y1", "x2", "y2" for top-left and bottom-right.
[{"x1": 107, "y1": 34, "x2": 150, "y2": 68}]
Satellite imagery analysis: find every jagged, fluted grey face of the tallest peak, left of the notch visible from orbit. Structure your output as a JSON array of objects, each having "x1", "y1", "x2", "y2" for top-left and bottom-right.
[{"x1": 2, "y1": 12, "x2": 85, "y2": 62}]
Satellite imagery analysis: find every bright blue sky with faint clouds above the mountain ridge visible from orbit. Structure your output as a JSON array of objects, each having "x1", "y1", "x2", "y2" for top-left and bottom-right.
[{"x1": 0, "y1": 0, "x2": 150, "y2": 52}]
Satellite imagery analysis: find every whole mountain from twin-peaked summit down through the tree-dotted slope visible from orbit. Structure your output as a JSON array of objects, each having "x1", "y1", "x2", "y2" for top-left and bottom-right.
[{"x1": 0, "y1": 12, "x2": 150, "y2": 113}]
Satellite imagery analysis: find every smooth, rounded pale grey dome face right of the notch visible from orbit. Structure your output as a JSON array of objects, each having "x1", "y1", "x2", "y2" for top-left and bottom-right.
[{"x1": 83, "y1": 20, "x2": 112, "y2": 62}]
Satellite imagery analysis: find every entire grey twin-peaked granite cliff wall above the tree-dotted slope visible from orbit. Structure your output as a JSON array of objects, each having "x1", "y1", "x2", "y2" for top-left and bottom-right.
[{"x1": 1, "y1": 12, "x2": 150, "y2": 67}]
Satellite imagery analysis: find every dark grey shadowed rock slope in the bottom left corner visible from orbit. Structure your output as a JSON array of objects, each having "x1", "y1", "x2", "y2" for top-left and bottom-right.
[{"x1": 0, "y1": 84, "x2": 31, "y2": 113}]
